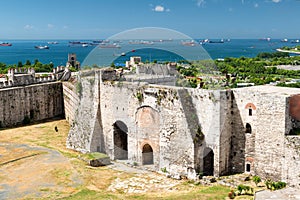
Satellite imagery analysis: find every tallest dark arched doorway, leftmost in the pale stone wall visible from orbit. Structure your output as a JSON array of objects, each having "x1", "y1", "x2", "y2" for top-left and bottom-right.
[{"x1": 113, "y1": 121, "x2": 128, "y2": 160}]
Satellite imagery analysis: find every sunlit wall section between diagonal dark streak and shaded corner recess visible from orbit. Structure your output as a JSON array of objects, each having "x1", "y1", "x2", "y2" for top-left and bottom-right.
[{"x1": 190, "y1": 89, "x2": 231, "y2": 176}]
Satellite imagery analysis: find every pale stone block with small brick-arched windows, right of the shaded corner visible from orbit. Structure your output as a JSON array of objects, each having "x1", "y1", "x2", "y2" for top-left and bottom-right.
[{"x1": 232, "y1": 87, "x2": 286, "y2": 180}]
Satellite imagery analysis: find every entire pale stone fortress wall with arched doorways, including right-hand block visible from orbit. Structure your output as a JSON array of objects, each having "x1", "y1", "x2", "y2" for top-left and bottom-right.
[{"x1": 64, "y1": 71, "x2": 300, "y2": 186}]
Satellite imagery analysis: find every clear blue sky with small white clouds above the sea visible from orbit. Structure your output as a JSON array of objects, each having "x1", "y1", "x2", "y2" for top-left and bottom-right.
[{"x1": 0, "y1": 0, "x2": 300, "y2": 39}]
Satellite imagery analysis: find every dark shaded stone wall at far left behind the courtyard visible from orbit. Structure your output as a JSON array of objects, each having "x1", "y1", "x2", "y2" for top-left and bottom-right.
[{"x1": 0, "y1": 82, "x2": 64, "y2": 127}]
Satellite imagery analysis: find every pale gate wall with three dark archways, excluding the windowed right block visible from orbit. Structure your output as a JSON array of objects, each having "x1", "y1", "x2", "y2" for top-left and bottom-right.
[{"x1": 67, "y1": 69, "x2": 231, "y2": 175}]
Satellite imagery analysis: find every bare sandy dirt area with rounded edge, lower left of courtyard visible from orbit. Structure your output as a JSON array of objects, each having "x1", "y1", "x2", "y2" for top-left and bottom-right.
[{"x1": 0, "y1": 143, "x2": 81, "y2": 199}]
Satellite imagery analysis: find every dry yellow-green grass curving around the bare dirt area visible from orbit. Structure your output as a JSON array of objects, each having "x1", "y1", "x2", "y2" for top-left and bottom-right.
[{"x1": 0, "y1": 120, "x2": 251, "y2": 200}]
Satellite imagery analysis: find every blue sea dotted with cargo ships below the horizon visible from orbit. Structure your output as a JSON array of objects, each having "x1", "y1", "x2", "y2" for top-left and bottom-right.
[{"x1": 0, "y1": 39, "x2": 300, "y2": 66}]
